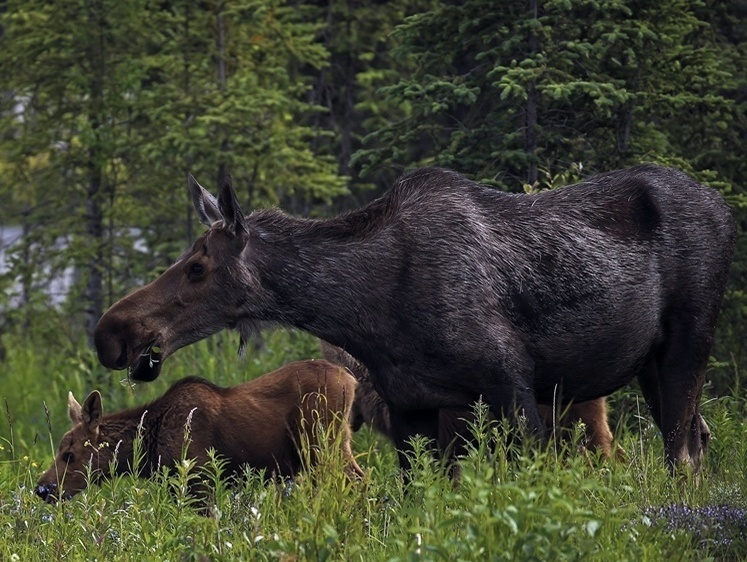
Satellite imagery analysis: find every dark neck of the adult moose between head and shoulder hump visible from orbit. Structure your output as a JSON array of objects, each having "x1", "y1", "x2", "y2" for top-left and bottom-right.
[{"x1": 248, "y1": 200, "x2": 399, "y2": 351}]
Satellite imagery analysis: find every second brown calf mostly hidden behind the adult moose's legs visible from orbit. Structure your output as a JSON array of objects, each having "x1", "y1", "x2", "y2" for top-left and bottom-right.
[{"x1": 319, "y1": 341, "x2": 625, "y2": 458}]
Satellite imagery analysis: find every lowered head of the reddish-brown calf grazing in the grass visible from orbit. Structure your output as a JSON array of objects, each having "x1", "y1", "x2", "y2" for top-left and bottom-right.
[{"x1": 36, "y1": 390, "x2": 115, "y2": 503}]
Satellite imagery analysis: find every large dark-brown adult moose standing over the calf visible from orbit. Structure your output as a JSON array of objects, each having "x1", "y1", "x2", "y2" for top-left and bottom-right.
[{"x1": 95, "y1": 165, "x2": 735, "y2": 470}]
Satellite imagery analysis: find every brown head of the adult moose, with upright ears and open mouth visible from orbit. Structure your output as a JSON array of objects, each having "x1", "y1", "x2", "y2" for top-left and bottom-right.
[{"x1": 94, "y1": 175, "x2": 260, "y2": 381}]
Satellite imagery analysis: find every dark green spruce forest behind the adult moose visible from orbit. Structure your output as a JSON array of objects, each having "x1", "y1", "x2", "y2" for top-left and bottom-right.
[{"x1": 0, "y1": 0, "x2": 747, "y2": 392}]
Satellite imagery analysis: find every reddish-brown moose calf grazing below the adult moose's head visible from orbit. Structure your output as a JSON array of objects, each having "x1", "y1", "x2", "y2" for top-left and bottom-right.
[{"x1": 36, "y1": 360, "x2": 363, "y2": 502}]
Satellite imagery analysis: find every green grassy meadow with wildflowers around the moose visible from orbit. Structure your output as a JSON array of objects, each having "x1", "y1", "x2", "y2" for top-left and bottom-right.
[{"x1": 0, "y1": 331, "x2": 747, "y2": 562}]
